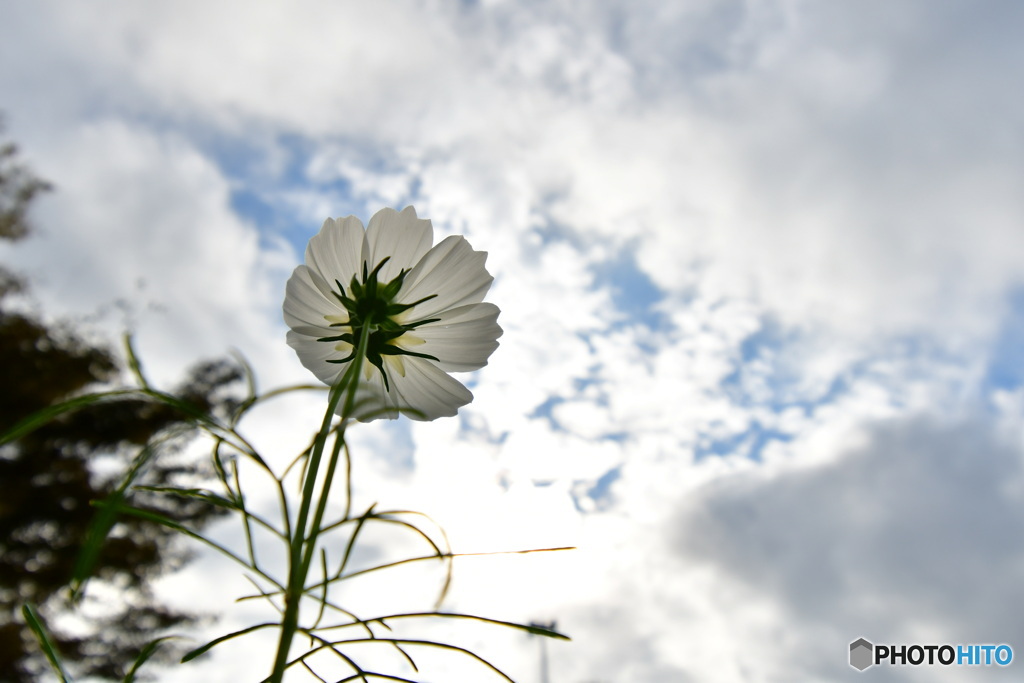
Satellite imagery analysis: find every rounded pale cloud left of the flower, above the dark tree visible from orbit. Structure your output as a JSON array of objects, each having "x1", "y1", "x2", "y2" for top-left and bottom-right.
[{"x1": 9, "y1": 121, "x2": 294, "y2": 381}]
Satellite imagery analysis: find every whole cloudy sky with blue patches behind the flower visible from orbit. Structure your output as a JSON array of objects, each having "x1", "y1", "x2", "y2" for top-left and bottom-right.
[{"x1": 0, "y1": 0, "x2": 1024, "y2": 683}]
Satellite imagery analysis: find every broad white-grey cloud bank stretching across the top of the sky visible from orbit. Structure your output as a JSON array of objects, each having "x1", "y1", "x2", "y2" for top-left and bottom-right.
[{"x1": 9, "y1": 2, "x2": 1024, "y2": 338}]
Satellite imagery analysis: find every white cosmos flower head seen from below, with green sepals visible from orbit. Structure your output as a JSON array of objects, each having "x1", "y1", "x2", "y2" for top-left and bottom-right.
[{"x1": 285, "y1": 207, "x2": 502, "y2": 420}]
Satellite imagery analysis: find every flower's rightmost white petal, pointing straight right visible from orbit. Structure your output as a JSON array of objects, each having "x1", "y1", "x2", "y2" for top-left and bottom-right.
[{"x1": 409, "y1": 303, "x2": 503, "y2": 373}]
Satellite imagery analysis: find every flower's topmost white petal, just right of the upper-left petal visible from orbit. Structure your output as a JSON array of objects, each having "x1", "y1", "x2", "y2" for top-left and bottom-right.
[{"x1": 367, "y1": 206, "x2": 434, "y2": 283}]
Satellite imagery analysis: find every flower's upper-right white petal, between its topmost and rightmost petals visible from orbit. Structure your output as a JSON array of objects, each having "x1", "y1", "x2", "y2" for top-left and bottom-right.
[{"x1": 397, "y1": 236, "x2": 495, "y2": 321}]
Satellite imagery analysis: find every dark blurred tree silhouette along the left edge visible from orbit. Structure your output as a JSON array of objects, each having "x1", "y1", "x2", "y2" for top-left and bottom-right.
[{"x1": 0, "y1": 126, "x2": 241, "y2": 683}]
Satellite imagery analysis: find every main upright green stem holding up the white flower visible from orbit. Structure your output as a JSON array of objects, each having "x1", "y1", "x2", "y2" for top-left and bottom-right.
[{"x1": 270, "y1": 319, "x2": 373, "y2": 683}]
